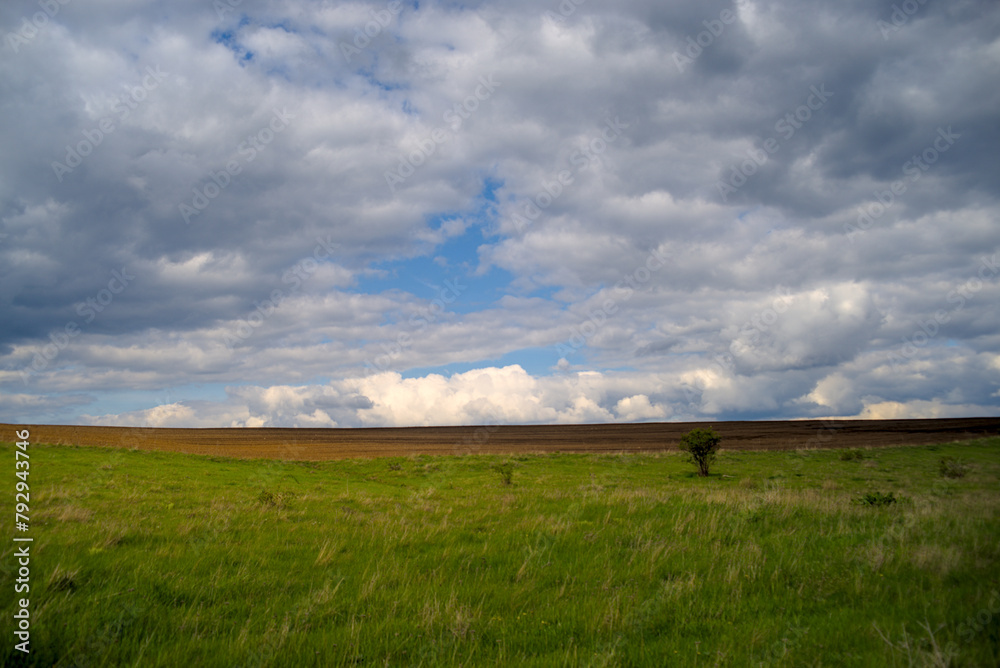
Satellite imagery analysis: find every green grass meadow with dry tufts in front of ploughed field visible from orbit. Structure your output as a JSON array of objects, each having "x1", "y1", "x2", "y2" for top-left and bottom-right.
[{"x1": 0, "y1": 438, "x2": 1000, "y2": 668}]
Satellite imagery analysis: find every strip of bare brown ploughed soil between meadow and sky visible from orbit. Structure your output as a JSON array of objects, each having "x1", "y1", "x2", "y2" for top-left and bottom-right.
[{"x1": 0, "y1": 418, "x2": 1000, "y2": 460}]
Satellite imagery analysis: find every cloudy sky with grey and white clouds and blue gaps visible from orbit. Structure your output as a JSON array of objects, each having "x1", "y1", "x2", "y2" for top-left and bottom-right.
[{"x1": 0, "y1": 0, "x2": 1000, "y2": 426}]
